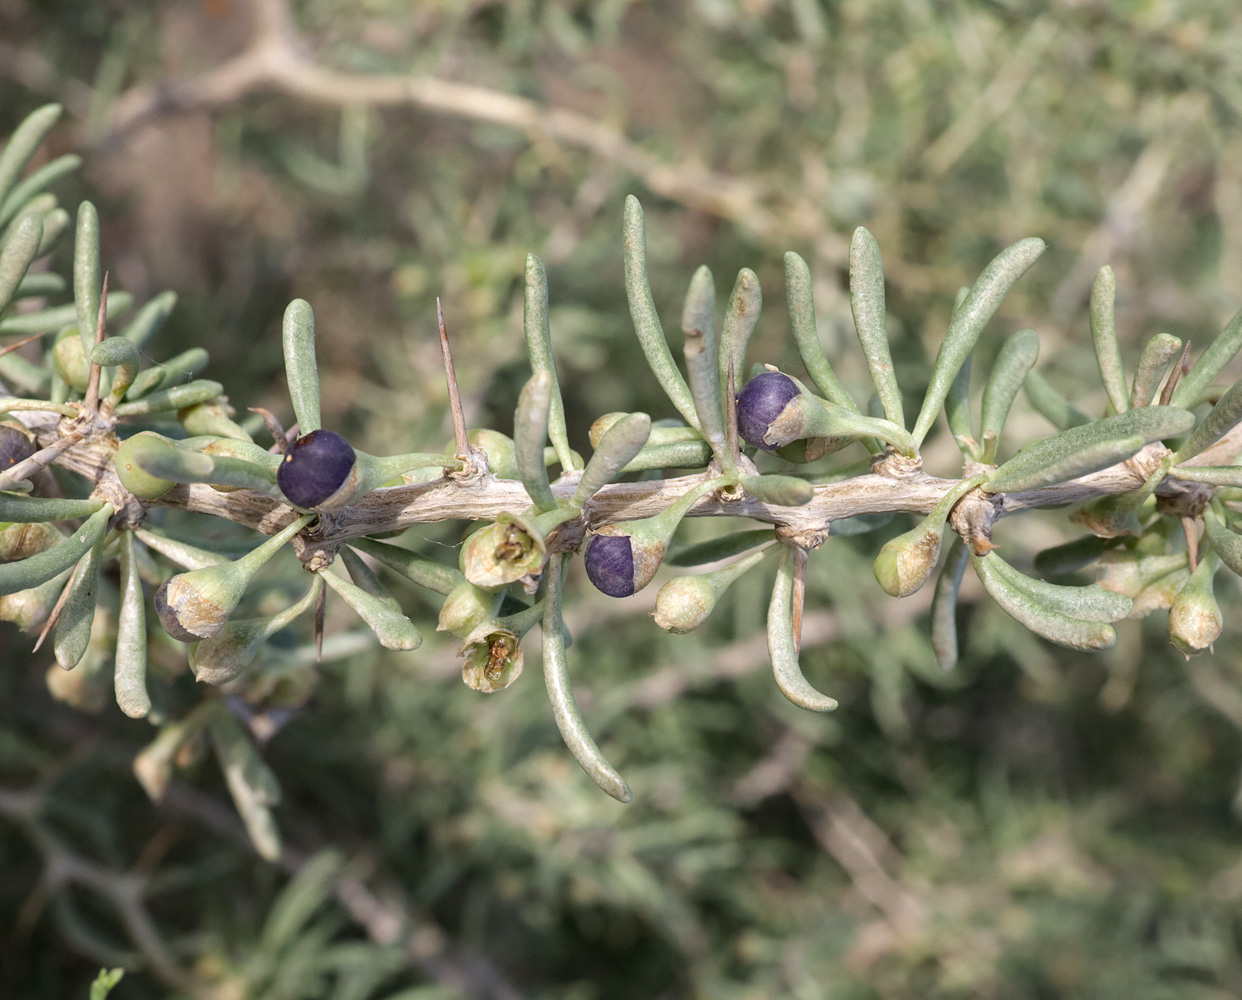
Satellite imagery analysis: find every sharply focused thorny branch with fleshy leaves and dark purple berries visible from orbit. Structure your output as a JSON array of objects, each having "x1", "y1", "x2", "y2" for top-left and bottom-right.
[{"x1": 0, "y1": 106, "x2": 1242, "y2": 857}]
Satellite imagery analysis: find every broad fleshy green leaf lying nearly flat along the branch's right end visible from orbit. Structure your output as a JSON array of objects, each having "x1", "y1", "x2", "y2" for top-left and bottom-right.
[{"x1": 982, "y1": 406, "x2": 1195, "y2": 493}]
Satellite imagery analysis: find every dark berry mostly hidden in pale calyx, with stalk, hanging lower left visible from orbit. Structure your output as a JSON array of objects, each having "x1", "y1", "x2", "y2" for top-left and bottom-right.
[{"x1": 155, "y1": 514, "x2": 314, "y2": 642}]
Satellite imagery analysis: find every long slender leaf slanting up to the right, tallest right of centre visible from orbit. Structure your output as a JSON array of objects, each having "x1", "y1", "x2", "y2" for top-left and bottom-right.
[{"x1": 913, "y1": 237, "x2": 1045, "y2": 445}]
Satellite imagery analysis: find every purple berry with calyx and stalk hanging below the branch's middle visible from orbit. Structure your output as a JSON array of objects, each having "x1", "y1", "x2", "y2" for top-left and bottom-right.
[{"x1": 584, "y1": 478, "x2": 725, "y2": 598}]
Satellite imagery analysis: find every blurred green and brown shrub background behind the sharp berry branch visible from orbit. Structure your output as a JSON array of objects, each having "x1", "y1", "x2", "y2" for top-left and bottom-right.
[{"x1": 0, "y1": 0, "x2": 1242, "y2": 1000}]
